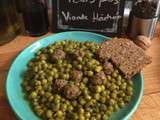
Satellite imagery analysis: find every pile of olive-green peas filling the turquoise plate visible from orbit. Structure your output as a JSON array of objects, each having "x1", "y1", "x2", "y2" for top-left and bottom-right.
[{"x1": 22, "y1": 40, "x2": 133, "y2": 120}]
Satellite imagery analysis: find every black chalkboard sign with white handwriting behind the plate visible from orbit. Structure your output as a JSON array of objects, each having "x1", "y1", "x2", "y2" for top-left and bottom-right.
[{"x1": 52, "y1": 0, "x2": 125, "y2": 35}]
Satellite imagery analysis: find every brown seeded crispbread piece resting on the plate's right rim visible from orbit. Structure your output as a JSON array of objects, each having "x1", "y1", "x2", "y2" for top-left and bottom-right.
[{"x1": 98, "y1": 38, "x2": 151, "y2": 79}]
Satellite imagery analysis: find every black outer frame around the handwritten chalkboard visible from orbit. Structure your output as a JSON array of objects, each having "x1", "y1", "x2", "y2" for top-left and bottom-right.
[{"x1": 51, "y1": 0, "x2": 126, "y2": 37}]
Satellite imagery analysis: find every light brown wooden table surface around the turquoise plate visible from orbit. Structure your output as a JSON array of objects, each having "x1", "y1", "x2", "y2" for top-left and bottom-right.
[{"x1": 0, "y1": 24, "x2": 160, "y2": 120}]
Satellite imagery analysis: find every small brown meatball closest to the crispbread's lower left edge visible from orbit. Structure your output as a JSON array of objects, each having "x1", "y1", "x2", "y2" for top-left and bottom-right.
[{"x1": 103, "y1": 61, "x2": 114, "y2": 75}]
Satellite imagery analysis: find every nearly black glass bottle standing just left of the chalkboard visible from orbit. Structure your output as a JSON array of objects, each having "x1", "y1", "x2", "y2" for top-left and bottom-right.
[{"x1": 23, "y1": 0, "x2": 48, "y2": 36}]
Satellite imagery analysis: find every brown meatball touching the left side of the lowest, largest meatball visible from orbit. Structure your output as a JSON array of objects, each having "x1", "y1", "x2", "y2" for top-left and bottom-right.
[{"x1": 53, "y1": 79, "x2": 67, "y2": 91}]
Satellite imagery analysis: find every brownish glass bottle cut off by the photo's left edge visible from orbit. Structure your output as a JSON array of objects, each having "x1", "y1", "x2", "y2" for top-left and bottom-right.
[{"x1": 0, "y1": 0, "x2": 21, "y2": 45}]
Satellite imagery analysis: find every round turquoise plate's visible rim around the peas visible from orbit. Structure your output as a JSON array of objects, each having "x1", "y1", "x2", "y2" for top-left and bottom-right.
[{"x1": 6, "y1": 31, "x2": 144, "y2": 120}]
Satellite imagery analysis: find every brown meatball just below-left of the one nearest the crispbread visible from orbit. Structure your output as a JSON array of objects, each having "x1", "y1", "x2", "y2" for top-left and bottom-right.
[{"x1": 91, "y1": 71, "x2": 106, "y2": 85}]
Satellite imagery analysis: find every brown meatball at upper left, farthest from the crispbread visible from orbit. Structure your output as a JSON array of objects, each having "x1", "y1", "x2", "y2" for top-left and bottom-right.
[{"x1": 51, "y1": 49, "x2": 66, "y2": 62}]
